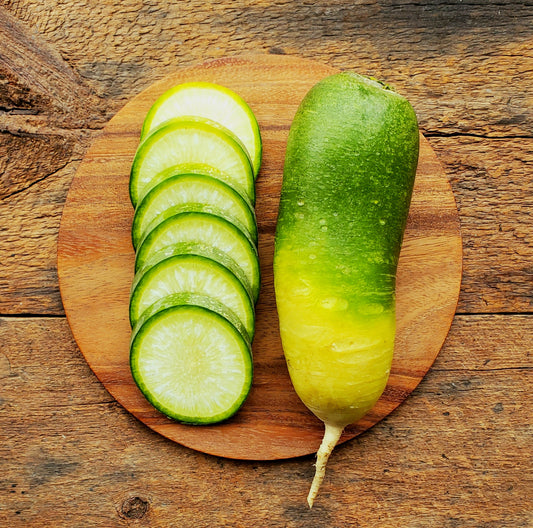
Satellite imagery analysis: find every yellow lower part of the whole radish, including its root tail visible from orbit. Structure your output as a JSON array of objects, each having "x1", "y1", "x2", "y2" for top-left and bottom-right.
[{"x1": 275, "y1": 262, "x2": 395, "y2": 507}]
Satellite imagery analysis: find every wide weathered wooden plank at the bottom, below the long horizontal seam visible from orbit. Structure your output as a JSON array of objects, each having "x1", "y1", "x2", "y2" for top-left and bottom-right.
[{"x1": 0, "y1": 316, "x2": 533, "y2": 528}]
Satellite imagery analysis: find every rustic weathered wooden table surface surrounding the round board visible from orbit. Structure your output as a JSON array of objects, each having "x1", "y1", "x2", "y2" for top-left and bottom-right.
[{"x1": 0, "y1": 0, "x2": 533, "y2": 528}]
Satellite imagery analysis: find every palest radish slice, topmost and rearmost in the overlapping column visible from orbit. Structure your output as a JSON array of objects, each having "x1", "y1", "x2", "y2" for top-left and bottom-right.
[{"x1": 141, "y1": 82, "x2": 262, "y2": 176}]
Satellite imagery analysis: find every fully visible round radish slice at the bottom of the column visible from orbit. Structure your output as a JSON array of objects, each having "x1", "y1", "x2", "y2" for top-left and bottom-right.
[{"x1": 130, "y1": 305, "x2": 252, "y2": 424}]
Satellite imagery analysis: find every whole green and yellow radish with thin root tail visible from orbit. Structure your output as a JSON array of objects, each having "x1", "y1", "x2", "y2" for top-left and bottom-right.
[{"x1": 274, "y1": 72, "x2": 419, "y2": 507}]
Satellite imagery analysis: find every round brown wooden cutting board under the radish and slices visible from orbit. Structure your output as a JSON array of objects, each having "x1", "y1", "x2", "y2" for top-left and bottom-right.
[{"x1": 58, "y1": 55, "x2": 462, "y2": 460}]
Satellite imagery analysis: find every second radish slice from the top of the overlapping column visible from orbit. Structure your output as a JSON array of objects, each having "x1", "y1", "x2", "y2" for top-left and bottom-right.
[{"x1": 130, "y1": 118, "x2": 255, "y2": 207}]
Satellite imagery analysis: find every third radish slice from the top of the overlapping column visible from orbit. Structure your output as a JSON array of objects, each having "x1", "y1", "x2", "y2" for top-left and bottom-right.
[{"x1": 132, "y1": 174, "x2": 257, "y2": 248}]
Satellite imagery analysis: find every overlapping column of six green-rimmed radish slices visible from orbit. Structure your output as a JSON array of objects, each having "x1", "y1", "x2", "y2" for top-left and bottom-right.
[{"x1": 130, "y1": 83, "x2": 262, "y2": 424}]
